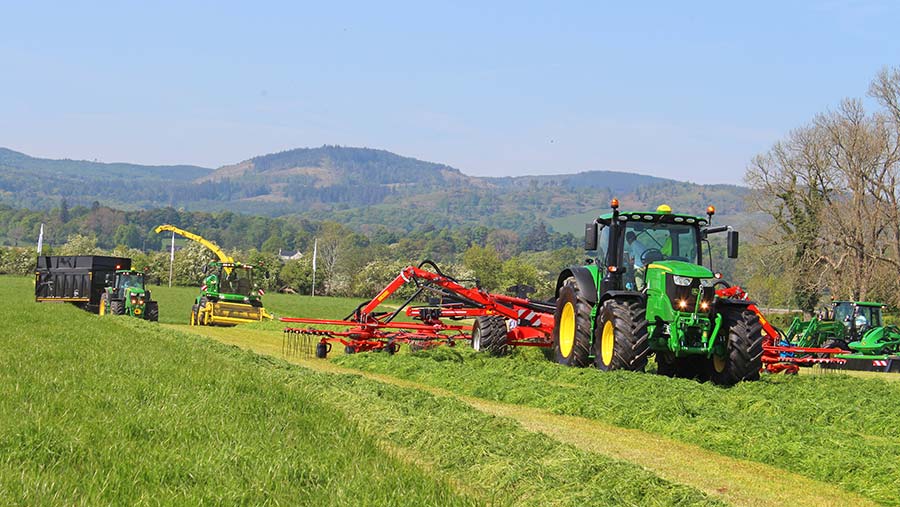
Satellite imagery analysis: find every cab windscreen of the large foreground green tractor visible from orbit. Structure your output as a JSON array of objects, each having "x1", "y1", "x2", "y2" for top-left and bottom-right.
[{"x1": 625, "y1": 221, "x2": 700, "y2": 268}]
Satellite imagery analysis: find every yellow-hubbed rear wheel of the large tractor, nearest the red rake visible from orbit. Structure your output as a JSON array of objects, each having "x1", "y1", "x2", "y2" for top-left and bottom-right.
[{"x1": 553, "y1": 277, "x2": 591, "y2": 368}]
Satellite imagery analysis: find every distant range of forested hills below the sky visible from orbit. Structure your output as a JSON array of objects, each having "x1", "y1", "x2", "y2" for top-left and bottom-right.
[{"x1": 0, "y1": 146, "x2": 746, "y2": 233}]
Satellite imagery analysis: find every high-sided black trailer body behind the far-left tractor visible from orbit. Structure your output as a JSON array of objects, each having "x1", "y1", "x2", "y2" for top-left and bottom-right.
[{"x1": 34, "y1": 255, "x2": 131, "y2": 311}]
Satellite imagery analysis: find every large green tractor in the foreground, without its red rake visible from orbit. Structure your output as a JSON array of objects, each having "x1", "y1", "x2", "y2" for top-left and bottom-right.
[{"x1": 553, "y1": 199, "x2": 763, "y2": 385}]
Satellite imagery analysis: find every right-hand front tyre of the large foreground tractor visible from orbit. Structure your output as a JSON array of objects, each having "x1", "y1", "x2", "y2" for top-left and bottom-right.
[{"x1": 709, "y1": 306, "x2": 763, "y2": 386}]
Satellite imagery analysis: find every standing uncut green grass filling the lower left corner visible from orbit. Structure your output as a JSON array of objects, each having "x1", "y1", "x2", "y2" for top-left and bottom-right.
[{"x1": 0, "y1": 277, "x2": 472, "y2": 505}]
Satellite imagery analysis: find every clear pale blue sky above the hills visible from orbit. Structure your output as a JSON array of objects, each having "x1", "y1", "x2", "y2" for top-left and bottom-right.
[{"x1": 0, "y1": 1, "x2": 900, "y2": 183}]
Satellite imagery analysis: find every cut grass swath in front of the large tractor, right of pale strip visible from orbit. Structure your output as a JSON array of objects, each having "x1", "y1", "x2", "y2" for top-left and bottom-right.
[{"x1": 336, "y1": 348, "x2": 900, "y2": 505}]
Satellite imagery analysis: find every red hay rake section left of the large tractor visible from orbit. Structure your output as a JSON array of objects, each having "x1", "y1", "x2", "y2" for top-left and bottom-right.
[{"x1": 280, "y1": 261, "x2": 554, "y2": 358}]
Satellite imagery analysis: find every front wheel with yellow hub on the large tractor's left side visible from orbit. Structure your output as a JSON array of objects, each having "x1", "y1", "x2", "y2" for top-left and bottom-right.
[{"x1": 594, "y1": 299, "x2": 650, "y2": 371}]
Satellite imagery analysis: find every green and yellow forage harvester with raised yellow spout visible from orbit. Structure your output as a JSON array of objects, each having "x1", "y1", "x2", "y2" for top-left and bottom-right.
[{"x1": 156, "y1": 225, "x2": 272, "y2": 326}]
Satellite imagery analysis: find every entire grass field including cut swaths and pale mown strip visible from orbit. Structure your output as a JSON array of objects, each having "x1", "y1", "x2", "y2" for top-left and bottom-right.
[{"x1": 0, "y1": 277, "x2": 900, "y2": 505}]
